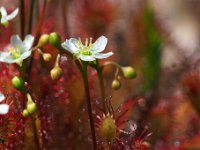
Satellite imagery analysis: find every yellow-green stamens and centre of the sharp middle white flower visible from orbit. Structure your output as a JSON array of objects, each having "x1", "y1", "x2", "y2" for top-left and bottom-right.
[{"x1": 78, "y1": 38, "x2": 92, "y2": 56}]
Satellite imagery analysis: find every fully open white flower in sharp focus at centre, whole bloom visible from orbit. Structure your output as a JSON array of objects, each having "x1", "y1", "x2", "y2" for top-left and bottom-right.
[{"x1": 62, "y1": 36, "x2": 113, "y2": 61}]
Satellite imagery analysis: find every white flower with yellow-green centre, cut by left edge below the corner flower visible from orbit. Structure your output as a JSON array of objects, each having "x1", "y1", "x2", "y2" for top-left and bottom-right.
[{"x1": 0, "y1": 35, "x2": 34, "y2": 66}]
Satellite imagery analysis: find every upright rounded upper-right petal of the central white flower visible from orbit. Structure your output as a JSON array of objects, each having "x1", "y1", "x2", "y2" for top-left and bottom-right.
[{"x1": 91, "y1": 36, "x2": 108, "y2": 53}]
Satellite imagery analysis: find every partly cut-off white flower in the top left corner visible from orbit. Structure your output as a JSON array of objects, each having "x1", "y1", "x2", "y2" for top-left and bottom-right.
[{"x1": 0, "y1": 7, "x2": 19, "y2": 27}]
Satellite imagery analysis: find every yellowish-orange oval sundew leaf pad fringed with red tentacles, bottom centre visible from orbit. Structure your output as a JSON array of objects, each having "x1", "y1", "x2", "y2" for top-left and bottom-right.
[{"x1": 99, "y1": 116, "x2": 117, "y2": 142}]
